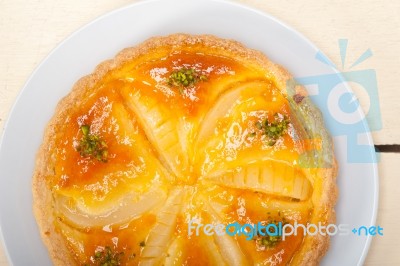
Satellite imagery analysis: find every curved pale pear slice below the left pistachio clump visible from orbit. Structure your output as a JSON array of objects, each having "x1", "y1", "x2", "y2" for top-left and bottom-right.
[{"x1": 55, "y1": 188, "x2": 166, "y2": 228}]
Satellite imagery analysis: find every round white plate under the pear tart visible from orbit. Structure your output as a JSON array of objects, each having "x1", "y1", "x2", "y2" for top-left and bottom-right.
[{"x1": 0, "y1": 0, "x2": 378, "y2": 266}]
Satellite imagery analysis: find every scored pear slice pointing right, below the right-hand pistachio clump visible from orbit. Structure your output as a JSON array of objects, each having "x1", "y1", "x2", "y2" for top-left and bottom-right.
[{"x1": 208, "y1": 160, "x2": 312, "y2": 200}]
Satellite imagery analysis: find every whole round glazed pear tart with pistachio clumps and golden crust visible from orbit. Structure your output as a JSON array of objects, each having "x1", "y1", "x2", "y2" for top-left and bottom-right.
[{"x1": 33, "y1": 34, "x2": 337, "y2": 265}]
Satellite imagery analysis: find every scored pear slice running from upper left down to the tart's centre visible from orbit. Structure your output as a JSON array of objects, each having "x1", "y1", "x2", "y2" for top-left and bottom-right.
[{"x1": 123, "y1": 88, "x2": 187, "y2": 175}]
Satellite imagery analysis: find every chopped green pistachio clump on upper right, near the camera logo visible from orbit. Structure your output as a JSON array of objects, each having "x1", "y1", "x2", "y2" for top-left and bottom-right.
[{"x1": 255, "y1": 113, "x2": 290, "y2": 146}]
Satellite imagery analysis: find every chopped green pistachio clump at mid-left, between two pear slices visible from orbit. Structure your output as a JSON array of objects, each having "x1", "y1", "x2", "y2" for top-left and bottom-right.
[{"x1": 76, "y1": 125, "x2": 108, "y2": 163}]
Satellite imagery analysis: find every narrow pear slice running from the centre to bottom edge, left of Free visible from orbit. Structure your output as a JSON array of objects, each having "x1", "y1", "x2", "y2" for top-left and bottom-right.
[{"x1": 140, "y1": 189, "x2": 184, "y2": 265}]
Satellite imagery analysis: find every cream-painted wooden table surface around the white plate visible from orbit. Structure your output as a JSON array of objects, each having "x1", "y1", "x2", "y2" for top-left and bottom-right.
[{"x1": 0, "y1": 0, "x2": 400, "y2": 266}]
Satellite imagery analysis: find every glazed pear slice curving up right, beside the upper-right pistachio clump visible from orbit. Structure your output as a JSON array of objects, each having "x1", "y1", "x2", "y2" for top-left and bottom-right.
[{"x1": 194, "y1": 80, "x2": 285, "y2": 176}]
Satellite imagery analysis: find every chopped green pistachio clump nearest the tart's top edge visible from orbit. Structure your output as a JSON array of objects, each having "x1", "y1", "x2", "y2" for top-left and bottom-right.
[{"x1": 167, "y1": 67, "x2": 207, "y2": 92}]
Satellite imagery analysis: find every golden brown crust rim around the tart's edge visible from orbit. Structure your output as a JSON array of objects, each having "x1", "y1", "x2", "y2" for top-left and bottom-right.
[{"x1": 32, "y1": 34, "x2": 337, "y2": 265}]
